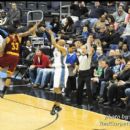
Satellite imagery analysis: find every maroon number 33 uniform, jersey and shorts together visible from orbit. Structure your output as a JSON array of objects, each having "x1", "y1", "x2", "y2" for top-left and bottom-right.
[{"x1": 0, "y1": 35, "x2": 21, "y2": 73}]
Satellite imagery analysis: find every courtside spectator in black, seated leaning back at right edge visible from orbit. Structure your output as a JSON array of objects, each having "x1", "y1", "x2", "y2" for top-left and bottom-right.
[{"x1": 104, "y1": 61, "x2": 130, "y2": 106}]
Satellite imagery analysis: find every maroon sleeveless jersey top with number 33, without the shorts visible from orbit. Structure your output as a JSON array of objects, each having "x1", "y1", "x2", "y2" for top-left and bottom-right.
[{"x1": 5, "y1": 35, "x2": 21, "y2": 54}]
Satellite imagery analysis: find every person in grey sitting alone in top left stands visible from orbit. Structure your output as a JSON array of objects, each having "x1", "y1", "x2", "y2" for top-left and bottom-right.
[{"x1": 6, "y1": 2, "x2": 20, "y2": 24}]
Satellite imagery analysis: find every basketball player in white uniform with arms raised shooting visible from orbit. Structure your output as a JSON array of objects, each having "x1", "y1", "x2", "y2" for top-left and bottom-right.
[{"x1": 47, "y1": 29, "x2": 68, "y2": 115}]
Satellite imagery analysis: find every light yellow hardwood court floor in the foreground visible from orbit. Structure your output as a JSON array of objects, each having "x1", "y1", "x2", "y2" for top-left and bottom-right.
[{"x1": 0, "y1": 94, "x2": 130, "y2": 130}]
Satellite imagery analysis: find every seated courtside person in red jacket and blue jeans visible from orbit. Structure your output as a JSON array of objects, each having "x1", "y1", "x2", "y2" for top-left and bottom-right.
[{"x1": 29, "y1": 49, "x2": 50, "y2": 83}]
